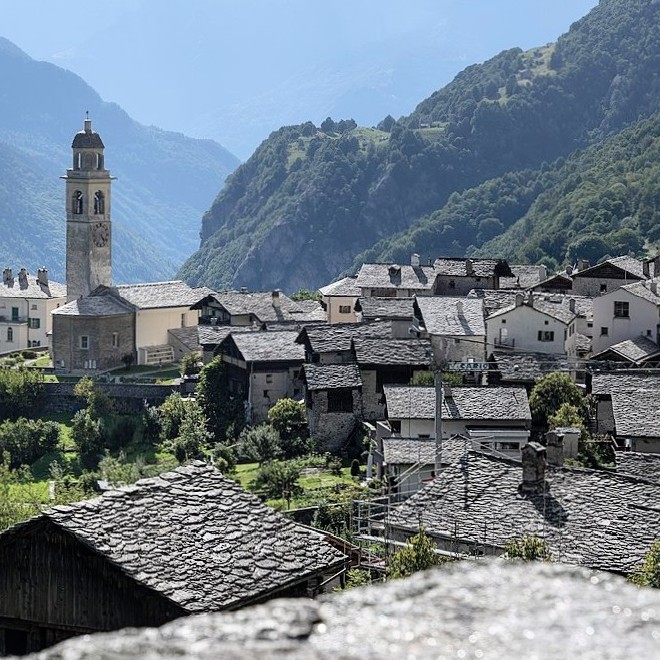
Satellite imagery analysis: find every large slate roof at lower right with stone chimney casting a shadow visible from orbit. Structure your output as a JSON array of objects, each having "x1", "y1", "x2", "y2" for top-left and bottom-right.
[{"x1": 390, "y1": 452, "x2": 660, "y2": 572}]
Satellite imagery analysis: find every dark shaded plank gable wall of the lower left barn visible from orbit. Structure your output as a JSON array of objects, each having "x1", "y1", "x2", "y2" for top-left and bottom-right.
[{"x1": 0, "y1": 520, "x2": 186, "y2": 653}]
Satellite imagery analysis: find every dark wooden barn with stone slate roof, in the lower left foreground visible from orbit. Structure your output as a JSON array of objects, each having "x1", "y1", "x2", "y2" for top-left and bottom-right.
[{"x1": 0, "y1": 464, "x2": 347, "y2": 655}]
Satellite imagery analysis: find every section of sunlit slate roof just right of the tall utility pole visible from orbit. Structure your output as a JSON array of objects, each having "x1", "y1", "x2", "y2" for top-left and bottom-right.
[{"x1": 442, "y1": 387, "x2": 532, "y2": 421}]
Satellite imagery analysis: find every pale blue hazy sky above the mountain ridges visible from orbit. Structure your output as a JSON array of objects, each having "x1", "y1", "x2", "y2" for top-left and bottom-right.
[{"x1": 0, "y1": 0, "x2": 597, "y2": 158}]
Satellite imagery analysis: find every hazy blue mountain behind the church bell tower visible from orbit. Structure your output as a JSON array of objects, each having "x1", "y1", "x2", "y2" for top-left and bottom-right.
[{"x1": 0, "y1": 38, "x2": 238, "y2": 282}]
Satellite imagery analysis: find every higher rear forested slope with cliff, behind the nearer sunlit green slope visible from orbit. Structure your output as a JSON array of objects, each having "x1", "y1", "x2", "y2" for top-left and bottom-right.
[{"x1": 181, "y1": 0, "x2": 660, "y2": 290}]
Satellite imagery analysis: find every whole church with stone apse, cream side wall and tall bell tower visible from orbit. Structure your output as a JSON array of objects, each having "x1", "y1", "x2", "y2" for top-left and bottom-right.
[{"x1": 51, "y1": 119, "x2": 204, "y2": 372}]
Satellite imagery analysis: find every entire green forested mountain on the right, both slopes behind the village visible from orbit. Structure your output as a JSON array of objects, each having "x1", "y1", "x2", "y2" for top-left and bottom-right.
[{"x1": 181, "y1": 0, "x2": 660, "y2": 291}]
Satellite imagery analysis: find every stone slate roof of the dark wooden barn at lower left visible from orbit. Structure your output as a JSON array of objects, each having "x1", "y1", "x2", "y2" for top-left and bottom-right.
[{"x1": 10, "y1": 463, "x2": 345, "y2": 612}]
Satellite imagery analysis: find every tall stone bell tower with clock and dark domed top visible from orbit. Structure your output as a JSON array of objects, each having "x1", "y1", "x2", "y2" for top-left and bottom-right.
[{"x1": 62, "y1": 118, "x2": 113, "y2": 302}]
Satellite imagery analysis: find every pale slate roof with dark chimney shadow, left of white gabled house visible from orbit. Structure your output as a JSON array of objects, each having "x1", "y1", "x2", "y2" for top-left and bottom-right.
[{"x1": 416, "y1": 296, "x2": 486, "y2": 337}]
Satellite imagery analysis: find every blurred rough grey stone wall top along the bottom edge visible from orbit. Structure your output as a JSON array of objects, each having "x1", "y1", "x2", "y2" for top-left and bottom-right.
[{"x1": 23, "y1": 560, "x2": 660, "y2": 660}]
